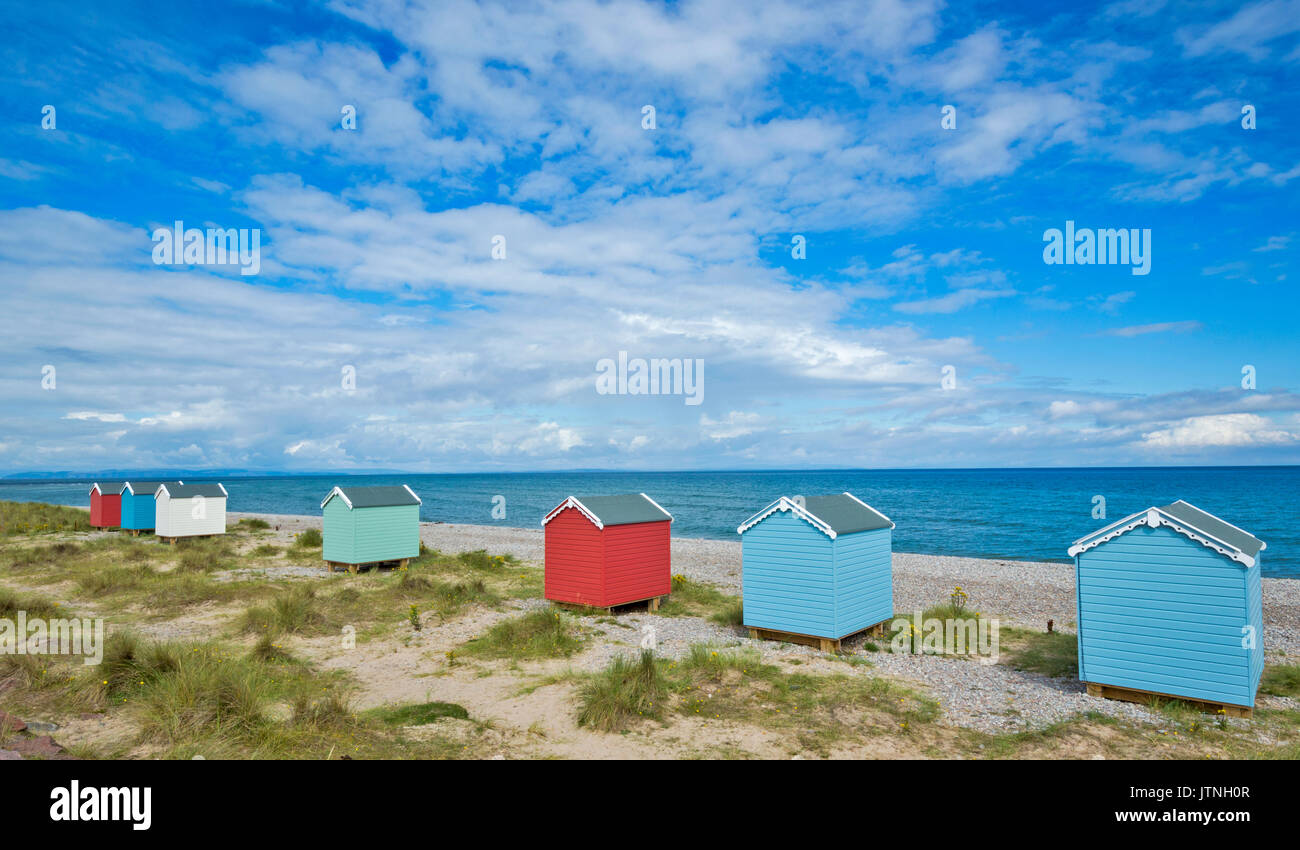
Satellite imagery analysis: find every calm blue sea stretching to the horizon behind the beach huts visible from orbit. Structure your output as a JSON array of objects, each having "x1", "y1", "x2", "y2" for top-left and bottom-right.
[{"x1": 0, "y1": 467, "x2": 1300, "y2": 577}]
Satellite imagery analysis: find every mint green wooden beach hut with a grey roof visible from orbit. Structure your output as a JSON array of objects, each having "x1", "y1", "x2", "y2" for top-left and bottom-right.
[{"x1": 321, "y1": 485, "x2": 420, "y2": 572}]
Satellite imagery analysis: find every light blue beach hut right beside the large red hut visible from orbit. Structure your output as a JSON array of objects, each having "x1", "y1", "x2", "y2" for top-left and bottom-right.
[{"x1": 736, "y1": 493, "x2": 894, "y2": 651}]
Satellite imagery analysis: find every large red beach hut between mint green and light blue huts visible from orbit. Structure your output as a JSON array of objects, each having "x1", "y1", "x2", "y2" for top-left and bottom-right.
[{"x1": 542, "y1": 493, "x2": 672, "y2": 611}]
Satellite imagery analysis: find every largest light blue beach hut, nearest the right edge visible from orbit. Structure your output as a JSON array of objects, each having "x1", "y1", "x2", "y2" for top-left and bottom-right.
[{"x1": 1069, "y1": 502, "x2": 1265, "y2": 716}]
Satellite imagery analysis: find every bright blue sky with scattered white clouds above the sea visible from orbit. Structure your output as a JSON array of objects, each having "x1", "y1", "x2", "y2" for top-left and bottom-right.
[{"x1": 0, "y1": 0, "x2": 1300, "y2": 472}]
